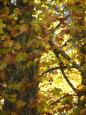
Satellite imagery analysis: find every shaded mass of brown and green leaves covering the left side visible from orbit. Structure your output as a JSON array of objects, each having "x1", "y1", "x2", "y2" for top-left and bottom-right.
[{"x1": 0, "y1": 0, "x2": 45, "y2": 114}]
